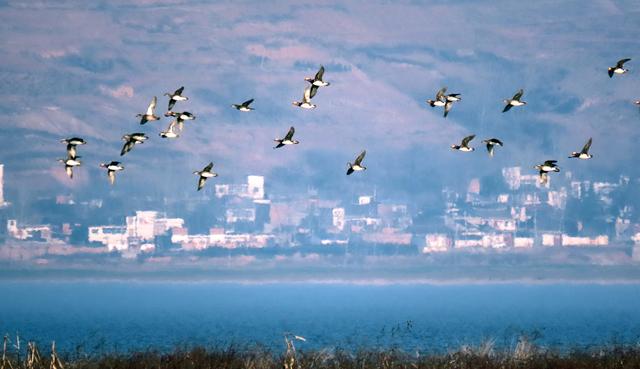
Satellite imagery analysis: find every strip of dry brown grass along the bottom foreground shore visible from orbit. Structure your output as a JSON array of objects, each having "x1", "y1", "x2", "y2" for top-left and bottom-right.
[{"x1": 0, "y1": 335, "x2": 640, "y2": 369}]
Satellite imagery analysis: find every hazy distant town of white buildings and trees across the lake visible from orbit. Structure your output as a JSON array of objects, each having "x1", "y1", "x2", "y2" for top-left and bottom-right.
[{"x1": 0, "y1": 161, "x2": 640, "y2": 264}]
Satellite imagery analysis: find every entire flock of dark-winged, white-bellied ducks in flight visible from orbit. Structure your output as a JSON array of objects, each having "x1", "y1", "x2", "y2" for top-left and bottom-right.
[{"x1": 58, "y1": 58, "x2": 640, "y2": 191}]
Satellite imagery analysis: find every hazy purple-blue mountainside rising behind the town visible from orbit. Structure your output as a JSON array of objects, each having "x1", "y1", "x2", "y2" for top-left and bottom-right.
[{"x1": 0, "y1": 0, "x2": 640, "y2": 200}]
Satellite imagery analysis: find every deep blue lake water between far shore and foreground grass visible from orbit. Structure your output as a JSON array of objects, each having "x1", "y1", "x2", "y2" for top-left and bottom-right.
[{"x1": 0, "y1": 282, "x2": 640, "y2": 353}]
